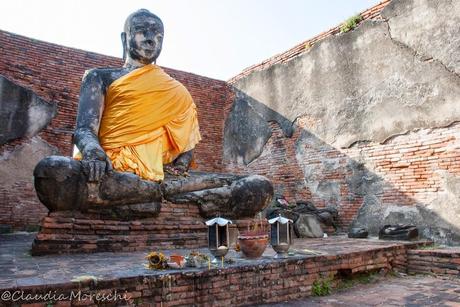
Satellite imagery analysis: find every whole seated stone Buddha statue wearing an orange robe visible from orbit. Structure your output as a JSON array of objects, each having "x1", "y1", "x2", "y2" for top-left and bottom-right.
[{"x1": 34, "y1": 9, "x2": 273, "y2": 219}]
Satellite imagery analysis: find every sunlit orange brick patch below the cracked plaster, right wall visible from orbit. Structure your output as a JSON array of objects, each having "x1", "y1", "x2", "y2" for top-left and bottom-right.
[{"x1": 344, "y1": 123, "x2": 460, "y2": 205}]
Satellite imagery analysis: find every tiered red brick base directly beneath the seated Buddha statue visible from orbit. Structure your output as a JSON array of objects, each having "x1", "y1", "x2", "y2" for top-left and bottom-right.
[{"x1": 32, "y1": 203, "x2": 207, "y2": 256}]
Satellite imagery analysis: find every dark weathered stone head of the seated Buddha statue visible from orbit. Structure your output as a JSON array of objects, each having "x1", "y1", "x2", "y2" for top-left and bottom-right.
[{"x1": 121, "y1": 9, "x2": 164, "y2": 66}]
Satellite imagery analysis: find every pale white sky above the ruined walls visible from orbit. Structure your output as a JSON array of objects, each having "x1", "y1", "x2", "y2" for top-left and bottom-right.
[{"x1": 0, "y1": 0, "x2": 381, "y2": 80}]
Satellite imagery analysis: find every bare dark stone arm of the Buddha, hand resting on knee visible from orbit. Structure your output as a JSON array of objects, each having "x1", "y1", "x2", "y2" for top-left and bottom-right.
[{"x1": 74, "y1": 70, "x2": 111, "y2": 181}]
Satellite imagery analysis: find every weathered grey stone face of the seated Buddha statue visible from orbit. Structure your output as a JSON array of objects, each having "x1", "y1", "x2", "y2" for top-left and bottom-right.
[{"x1": 126, "y1": 14, "x2": 164, "y2": 64}]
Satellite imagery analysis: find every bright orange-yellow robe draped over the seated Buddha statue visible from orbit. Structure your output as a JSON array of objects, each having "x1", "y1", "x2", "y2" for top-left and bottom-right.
[{"x1": 99, "y1": 64, "x2": 201, "y2": 181}]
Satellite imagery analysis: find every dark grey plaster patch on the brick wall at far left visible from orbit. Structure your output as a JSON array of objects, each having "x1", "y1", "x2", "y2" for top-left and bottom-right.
[{"x1": 0, "y1": 75, "x2": 56, "y2": 145}]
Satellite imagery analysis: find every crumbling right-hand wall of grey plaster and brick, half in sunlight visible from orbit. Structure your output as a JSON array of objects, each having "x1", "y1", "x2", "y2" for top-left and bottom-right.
[{"x1": 224, "y1": 0, "x2": 460, "y2": 243}]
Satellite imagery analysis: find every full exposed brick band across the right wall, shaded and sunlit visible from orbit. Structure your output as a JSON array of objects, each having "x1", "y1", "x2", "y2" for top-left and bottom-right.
[{"x1": 226, "y1": 114, "x2": 460, "y2": 227}]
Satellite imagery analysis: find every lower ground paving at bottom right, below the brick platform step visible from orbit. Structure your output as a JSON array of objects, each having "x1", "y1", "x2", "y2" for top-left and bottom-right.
[{"x1": 259, "y1": 275, "x2": 460, "y2": 307}]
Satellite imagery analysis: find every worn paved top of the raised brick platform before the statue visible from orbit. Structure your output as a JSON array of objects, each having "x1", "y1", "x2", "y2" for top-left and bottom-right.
[{"x1": 0, "y1": 233, "x2": 428, "y2": 289}]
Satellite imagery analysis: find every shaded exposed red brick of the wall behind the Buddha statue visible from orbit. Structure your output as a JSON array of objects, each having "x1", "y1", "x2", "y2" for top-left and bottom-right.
[{"x1": 0, "y1": 31, "x2": 229, "y2": 228}]
